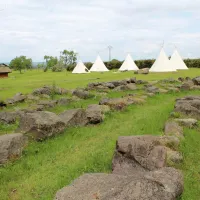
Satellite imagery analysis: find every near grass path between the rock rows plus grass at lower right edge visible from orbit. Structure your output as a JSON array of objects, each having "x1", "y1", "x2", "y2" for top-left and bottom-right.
[{"x1": 0, "y1": 91, "x2": 200, "y2": 200}]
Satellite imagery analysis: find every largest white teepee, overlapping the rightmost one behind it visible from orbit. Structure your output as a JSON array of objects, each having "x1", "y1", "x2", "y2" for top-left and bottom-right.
[{"x1": 149, "y1": 48, "x2": 176, "y2": 72}]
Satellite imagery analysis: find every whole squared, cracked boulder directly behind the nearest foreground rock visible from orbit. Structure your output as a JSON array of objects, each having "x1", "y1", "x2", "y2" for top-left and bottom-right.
[{"x1": 112, "y1": 136, "x2": 167, "y2": 174}]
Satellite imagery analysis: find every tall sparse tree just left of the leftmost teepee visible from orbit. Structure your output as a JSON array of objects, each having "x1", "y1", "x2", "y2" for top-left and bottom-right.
[{"x1": 62, "y1": 50, "x2": 77, "y2": 70}]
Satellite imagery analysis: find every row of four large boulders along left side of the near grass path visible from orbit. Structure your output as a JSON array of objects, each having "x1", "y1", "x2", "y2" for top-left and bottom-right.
[{"x1": 0, "y1": 104, "x2": 109, "y2": 164}]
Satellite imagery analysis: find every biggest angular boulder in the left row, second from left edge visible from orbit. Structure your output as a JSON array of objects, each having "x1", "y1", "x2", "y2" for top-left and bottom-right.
[{"x1": 18, "y1": 111, "x2": 66, "y2": 141}]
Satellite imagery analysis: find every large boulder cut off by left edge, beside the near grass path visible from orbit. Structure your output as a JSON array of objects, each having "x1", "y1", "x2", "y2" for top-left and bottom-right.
[{"x1": 0, "y1": 133, "x2": 27, "y2": 165}]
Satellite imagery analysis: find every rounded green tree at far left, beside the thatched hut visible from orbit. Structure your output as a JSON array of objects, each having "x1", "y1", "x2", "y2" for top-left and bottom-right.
[{"x1": 10, "y1": 56, "x2": 32, "y2": 74}]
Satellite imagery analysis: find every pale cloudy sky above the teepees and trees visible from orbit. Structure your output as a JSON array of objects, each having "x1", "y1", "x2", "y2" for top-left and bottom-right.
[{"x1": 0, "y1": 0, "x2": 200, "y2": 62}]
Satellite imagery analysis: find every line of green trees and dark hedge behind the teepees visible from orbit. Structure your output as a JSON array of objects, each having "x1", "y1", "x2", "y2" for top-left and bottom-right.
[{"x1": 10, "y1": 50, "x2": 200, "y2": 73}]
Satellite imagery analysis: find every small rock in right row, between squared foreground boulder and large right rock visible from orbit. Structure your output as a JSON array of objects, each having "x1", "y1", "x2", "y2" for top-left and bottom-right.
[{"x1": 165, "y1": 121, "x2": 183, "y2": 137}]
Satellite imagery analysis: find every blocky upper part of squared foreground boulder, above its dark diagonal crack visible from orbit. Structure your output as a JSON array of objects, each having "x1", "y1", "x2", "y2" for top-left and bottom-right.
[{"x1": 112, "y1": 136, "x2": 167, "y2": 171}]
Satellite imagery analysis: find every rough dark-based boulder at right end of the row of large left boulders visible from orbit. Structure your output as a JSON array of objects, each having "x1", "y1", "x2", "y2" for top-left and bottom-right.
[{"x1": 86, "y1": 104, "x2": 104, "y2": 124}]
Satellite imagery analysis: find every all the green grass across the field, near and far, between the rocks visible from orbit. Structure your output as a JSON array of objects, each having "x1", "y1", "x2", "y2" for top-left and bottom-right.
[{"x1": 0, "y1": 69, "x2": 200, "y2": 200}]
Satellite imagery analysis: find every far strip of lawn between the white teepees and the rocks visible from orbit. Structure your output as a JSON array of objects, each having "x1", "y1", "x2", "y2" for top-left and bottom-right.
[{"x1": 0, "y1": 69, "x2": 200, "y2": 100}]
